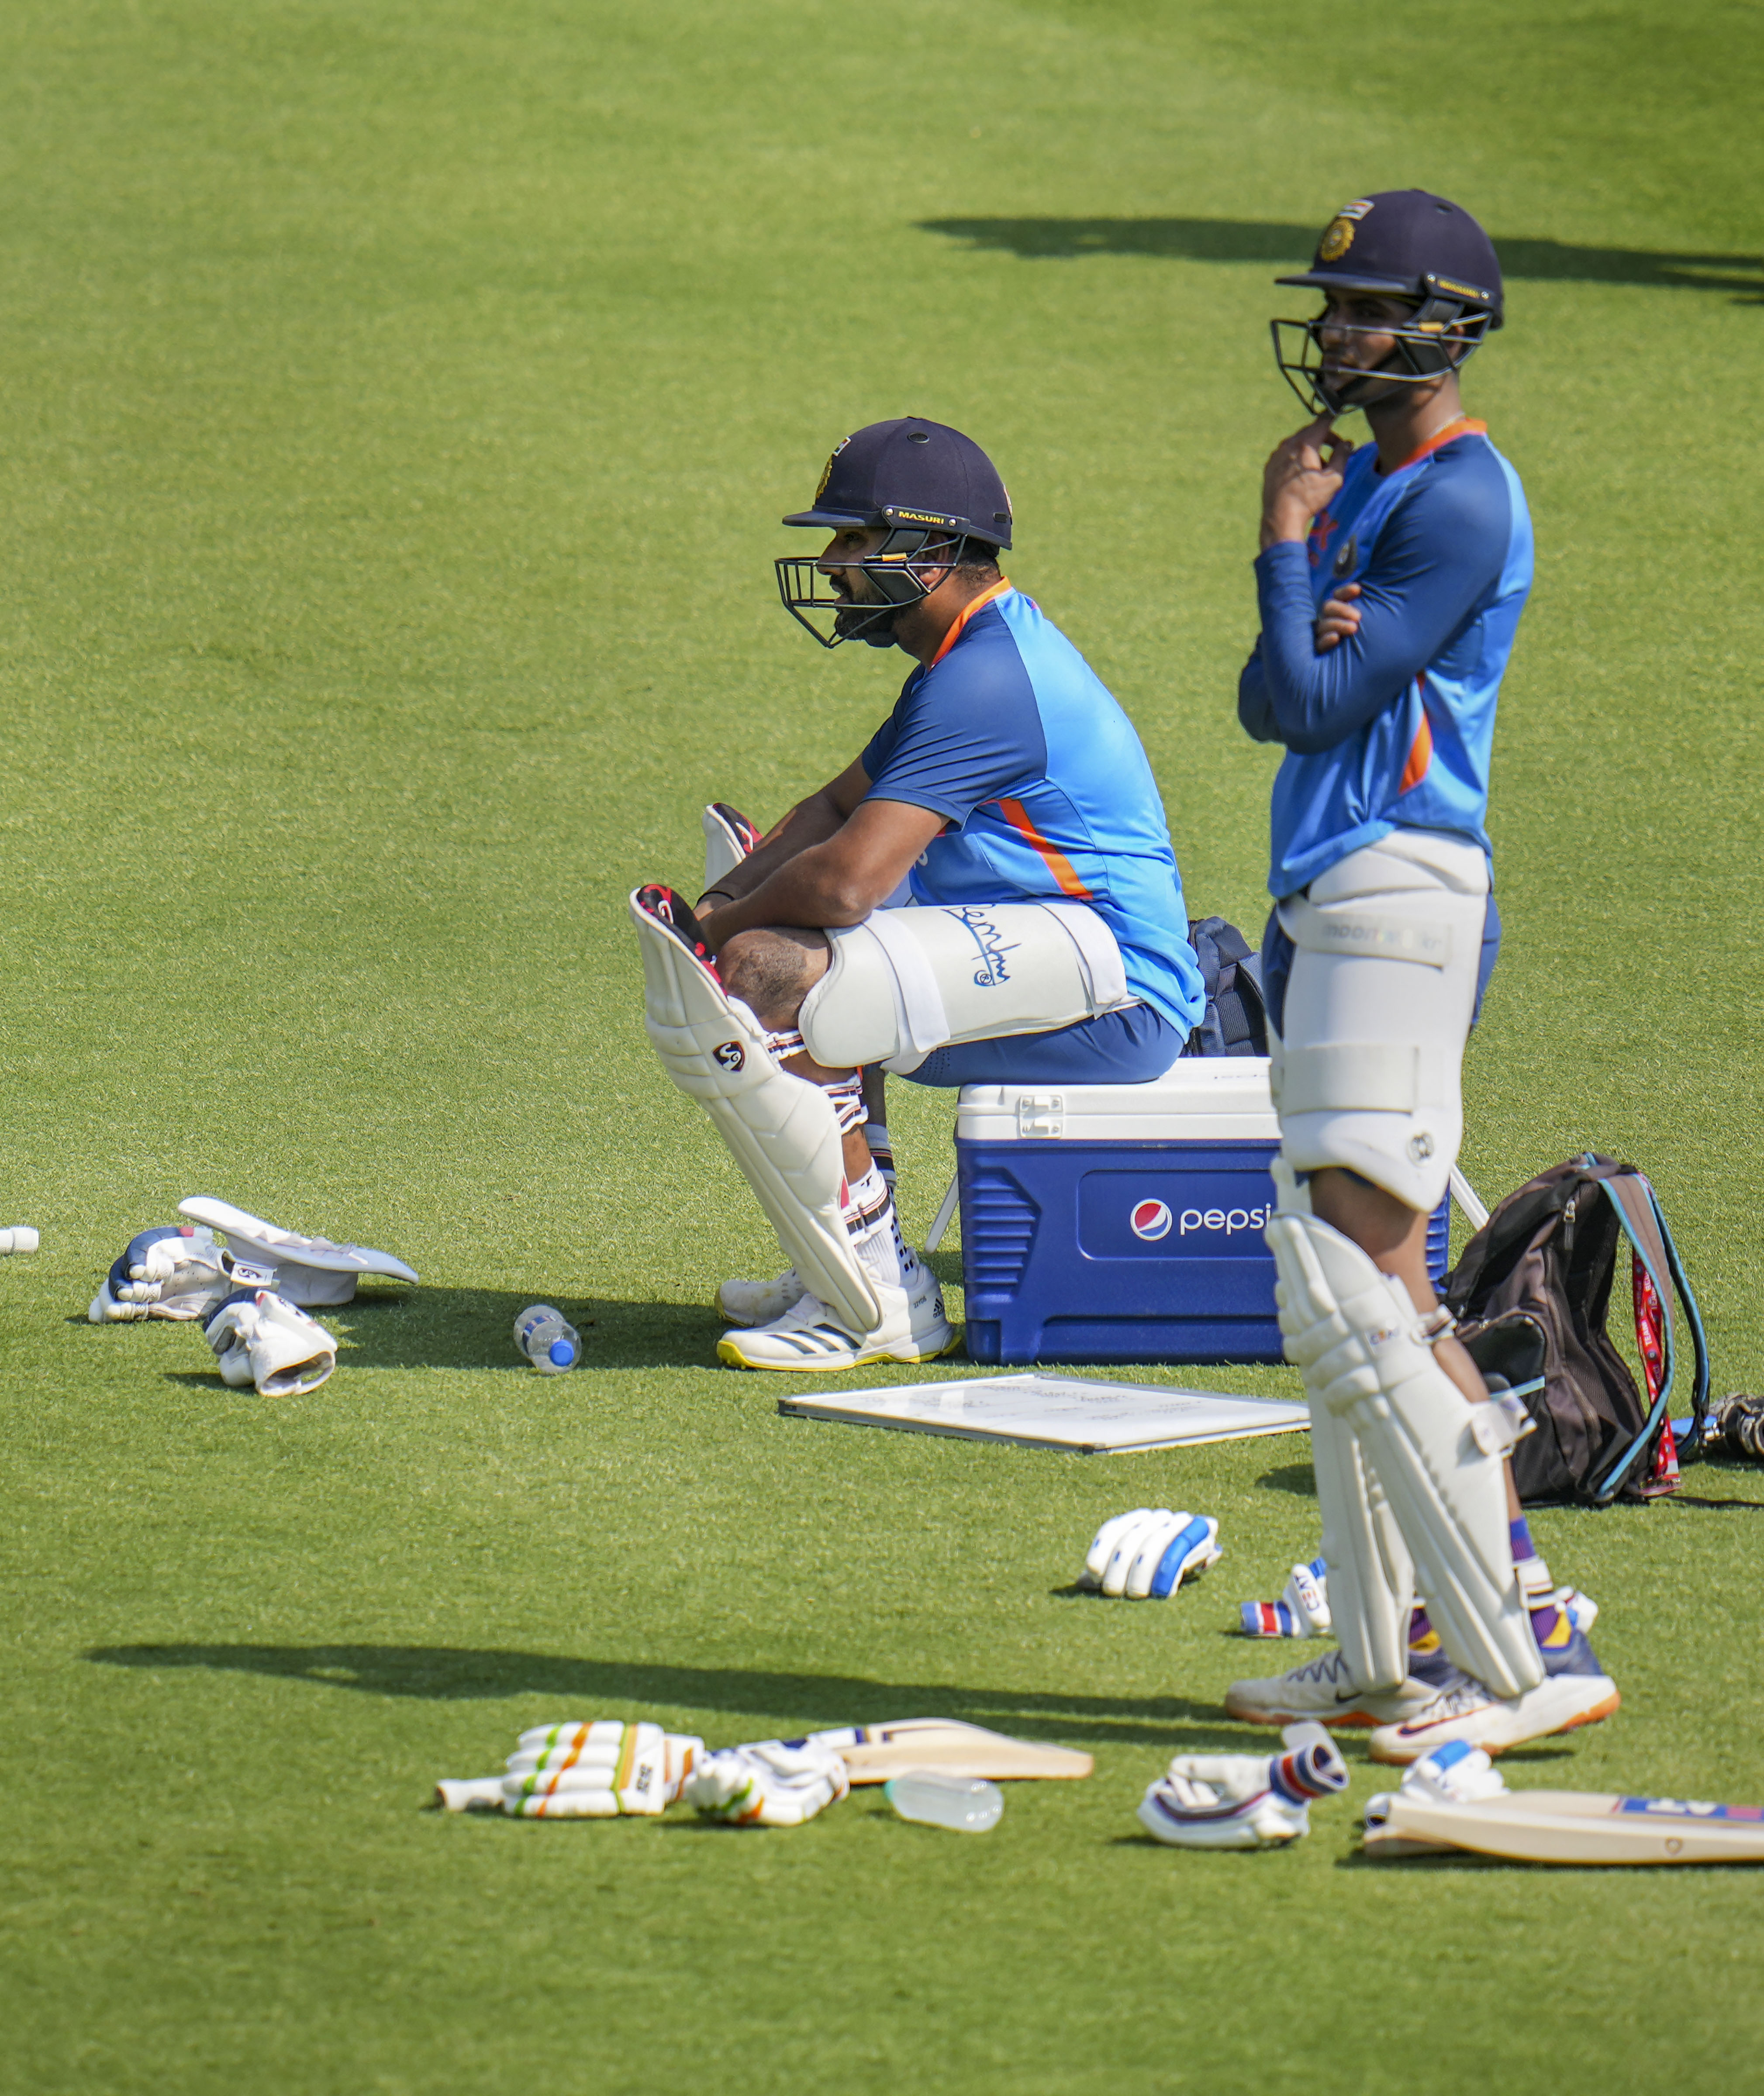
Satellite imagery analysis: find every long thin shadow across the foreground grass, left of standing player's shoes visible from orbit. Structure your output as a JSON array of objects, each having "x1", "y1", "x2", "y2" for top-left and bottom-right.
[{"x1": 86, "y1": 1645, "x2": 1248, "y2": 1746}]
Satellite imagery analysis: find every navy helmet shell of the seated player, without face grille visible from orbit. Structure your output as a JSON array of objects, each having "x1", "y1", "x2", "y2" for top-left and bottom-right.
[{"x1": 784, "y1": 415, "x2": 1011, "y2": 547}]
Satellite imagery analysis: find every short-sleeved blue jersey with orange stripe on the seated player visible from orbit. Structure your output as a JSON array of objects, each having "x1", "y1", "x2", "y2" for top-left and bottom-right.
[{"x1": 862, "y1": 583, "x2": 1206, "y2": 1033}]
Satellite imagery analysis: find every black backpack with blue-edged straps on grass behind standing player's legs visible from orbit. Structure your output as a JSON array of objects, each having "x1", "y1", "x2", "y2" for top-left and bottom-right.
[{"x1": 1445, "y1": 1151, "x2": 1709, "y2": 1507}]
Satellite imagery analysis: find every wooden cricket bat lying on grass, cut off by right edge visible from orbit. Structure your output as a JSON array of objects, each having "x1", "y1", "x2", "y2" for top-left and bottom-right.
[{"x1": 1367, "y1": 1777, "x2": 1764, "y2": 1863}]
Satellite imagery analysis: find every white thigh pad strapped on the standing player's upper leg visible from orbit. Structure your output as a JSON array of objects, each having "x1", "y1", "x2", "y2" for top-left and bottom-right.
[{"x1": 1275, "y1": 830, "x2": 1489, "y2": 1211}]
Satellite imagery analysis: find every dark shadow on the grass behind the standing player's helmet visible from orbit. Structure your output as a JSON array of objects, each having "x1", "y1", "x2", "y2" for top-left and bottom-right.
[{"x1": 919, "y1": 218, "x2": 1764, "y2": 306}]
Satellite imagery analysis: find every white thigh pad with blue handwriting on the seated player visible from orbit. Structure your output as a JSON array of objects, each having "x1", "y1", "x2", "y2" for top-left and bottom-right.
[{"x1": 797, "y1": 903, "x2": 1135, "y2": 1075}]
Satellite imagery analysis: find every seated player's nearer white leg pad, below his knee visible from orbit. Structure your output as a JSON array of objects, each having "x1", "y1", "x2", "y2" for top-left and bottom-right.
[{"x1": 632, "y1": 893, "x2": 881, "y2": 1333}]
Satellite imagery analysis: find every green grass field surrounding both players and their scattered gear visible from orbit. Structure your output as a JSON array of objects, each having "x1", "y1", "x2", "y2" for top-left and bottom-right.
[{"x1": 0, "y1": 0, "x2": 1764, "y2": 2096}]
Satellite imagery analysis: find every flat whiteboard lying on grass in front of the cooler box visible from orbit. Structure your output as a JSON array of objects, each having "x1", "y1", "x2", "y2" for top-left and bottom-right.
[{"x1": 778, "y1": 1375, "x2": 1311, "y2": 1455}]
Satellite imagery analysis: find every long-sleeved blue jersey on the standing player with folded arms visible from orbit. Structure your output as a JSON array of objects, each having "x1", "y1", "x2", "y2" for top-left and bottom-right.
[{"x1": 1238, "y1": 421, "x2": 1531, "y2": 899}]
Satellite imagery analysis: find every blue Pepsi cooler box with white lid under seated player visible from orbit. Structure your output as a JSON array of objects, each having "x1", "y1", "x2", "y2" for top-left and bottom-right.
[{"x1": 956, "y1": 1056, "x2": 1447, "y2": 1362}]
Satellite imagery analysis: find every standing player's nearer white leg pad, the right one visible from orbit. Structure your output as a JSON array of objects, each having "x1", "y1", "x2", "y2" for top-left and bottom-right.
[{"x1": 1267, "y1": 1213, "x2": 1544, "y2": 1696}]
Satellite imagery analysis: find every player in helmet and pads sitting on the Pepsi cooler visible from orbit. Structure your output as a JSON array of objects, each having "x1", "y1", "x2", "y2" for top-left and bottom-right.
[{"x1": 632, "y1": 417, "x2": 1206, "y2": 1375}]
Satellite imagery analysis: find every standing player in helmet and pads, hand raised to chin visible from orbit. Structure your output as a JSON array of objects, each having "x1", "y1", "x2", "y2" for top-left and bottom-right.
[{"x1": 1227, "y1": 189, "x2": 1617, "y2": 1761}]
